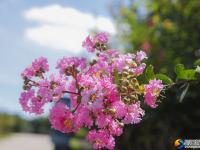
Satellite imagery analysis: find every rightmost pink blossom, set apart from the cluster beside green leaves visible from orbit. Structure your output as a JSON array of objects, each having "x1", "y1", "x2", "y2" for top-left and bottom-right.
[{"x1": 144, "y1": 79, "x2": 164, "y2": 108}]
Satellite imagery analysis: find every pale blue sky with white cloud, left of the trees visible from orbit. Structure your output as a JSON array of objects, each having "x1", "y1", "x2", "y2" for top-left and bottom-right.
[{"x1": 0, "y1": 0, "x2": 116, "y2": 118}]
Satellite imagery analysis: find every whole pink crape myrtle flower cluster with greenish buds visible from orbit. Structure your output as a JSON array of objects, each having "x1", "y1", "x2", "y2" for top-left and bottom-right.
[{"x1": 20, "y1": 33, "x2": 164, "y2": 149}]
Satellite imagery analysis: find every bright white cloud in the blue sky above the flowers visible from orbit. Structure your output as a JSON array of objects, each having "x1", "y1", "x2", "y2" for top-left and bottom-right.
[{"x1": 23, "y1": 5, "x2": 116, "y2": 53}]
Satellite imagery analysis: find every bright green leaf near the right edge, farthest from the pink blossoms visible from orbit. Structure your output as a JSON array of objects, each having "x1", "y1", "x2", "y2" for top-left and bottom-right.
[{"x1": 175, "y1": 64, "x2": 196, "y2": 80}]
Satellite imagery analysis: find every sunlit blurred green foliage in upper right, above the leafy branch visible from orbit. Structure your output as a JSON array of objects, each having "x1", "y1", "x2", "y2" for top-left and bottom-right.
[{"x1": 115, "y1": 0, "x2": 200, "y2": 75}]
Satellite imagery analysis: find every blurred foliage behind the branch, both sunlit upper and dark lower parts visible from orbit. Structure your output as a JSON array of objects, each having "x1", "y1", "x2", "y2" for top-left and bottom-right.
[{"x1": 112, "y1": 0, "x2": 200, "y2": 150}]
